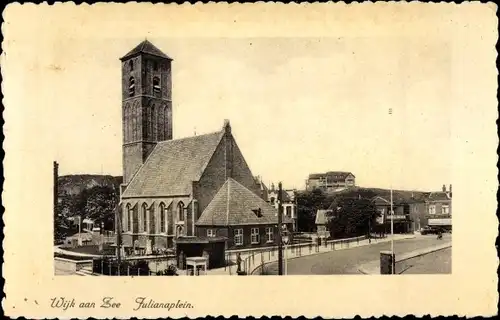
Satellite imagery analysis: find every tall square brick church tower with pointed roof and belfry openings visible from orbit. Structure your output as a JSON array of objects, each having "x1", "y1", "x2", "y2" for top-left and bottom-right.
[{"x1": 120, "y1": 40, "x2": 172, "y2": 185}]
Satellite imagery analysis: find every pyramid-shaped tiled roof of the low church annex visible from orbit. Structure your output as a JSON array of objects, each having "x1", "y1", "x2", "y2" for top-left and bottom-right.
[{"x1": 196, "y1": 178, "x2": 292, "y2": 226}]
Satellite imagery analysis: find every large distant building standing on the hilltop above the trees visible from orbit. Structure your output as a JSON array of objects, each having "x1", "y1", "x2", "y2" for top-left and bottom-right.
[{"x1": 306, "y1": 171, "x2": 356, "y2": 192}]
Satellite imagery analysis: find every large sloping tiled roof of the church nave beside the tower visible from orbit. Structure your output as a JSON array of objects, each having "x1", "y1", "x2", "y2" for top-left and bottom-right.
[{"x1": 122, "y1": 130, "x2": 224, "y2": 198}]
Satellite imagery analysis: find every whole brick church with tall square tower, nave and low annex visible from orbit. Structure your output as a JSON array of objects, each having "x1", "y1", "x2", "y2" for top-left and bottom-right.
[{"x1": 119, "y1": 40, "x2": 292, "y2": 253}]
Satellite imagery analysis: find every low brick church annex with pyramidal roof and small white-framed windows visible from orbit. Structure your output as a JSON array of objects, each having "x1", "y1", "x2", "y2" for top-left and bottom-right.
[{"x1": 196, "y1": 178, "x2": 292, "y2": 249}]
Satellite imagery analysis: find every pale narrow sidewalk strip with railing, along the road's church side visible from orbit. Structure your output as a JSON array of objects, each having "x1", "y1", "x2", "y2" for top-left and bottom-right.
[{"x1": 201, "y1": 234, "x2": 415, "y2": 275}]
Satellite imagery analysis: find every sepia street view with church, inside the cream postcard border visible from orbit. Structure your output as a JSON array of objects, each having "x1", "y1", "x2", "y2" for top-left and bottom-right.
[{"x1": 54, "y1": 38, "x2": 452, "y2": 276}]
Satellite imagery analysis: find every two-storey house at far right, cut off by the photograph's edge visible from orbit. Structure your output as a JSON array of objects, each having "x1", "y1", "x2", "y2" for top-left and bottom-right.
[{"x1": 426, "y1": 185, "x2": 452, "y2": 229}]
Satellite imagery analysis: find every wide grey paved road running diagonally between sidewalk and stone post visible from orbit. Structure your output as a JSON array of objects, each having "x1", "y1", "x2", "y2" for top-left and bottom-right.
[{"x1": 266, "y1": 234, "x2": 451, "y2": 275}]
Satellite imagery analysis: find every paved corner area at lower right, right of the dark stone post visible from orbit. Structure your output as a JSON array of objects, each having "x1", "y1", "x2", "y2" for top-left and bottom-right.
[{"x1": 396, "y1": 248, "x2": 451, "y2": 274}]
